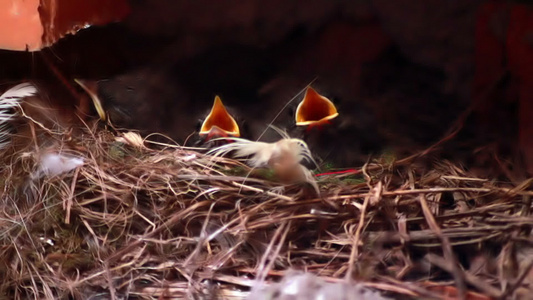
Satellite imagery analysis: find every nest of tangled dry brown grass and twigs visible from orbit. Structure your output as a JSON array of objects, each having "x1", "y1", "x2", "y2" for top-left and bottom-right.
[{"x1": 0, "y1": 127, "x2": 533, "y2": 299}]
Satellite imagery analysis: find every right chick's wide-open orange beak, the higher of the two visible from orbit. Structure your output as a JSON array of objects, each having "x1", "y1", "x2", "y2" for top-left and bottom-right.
[{"x1": 295, "y1": 87, "x2": 339, "y2": 126}]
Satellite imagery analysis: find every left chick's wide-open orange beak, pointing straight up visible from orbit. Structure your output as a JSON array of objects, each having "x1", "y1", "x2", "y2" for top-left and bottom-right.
[{"x1": 200, "y1": 96, "x2": 241, "y2": 138}]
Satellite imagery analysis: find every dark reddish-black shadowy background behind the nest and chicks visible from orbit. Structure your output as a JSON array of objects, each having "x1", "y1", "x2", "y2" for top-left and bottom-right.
[{"x1": 0, "y1": 0, "x2": 533, "y2": 173}]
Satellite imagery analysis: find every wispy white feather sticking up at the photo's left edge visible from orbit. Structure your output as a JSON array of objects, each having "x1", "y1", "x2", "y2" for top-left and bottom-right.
[{"x1": 0, "y1": 83, "x2": 37, "y2": 150}]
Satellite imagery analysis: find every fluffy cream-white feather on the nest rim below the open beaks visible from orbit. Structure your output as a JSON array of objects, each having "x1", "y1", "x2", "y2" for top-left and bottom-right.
[{"x1": 208, "y1": 130, "x2": 319, "y2": 194}]
